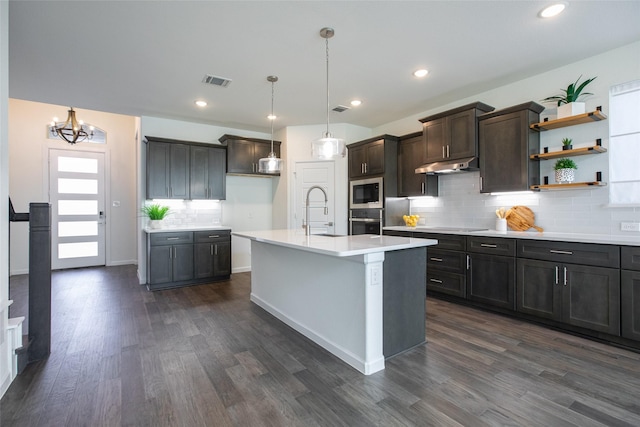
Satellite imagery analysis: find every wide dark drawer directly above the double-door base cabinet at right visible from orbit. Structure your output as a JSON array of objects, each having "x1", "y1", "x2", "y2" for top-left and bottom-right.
[{"x1": 518, "y1": 240, "x2": 620, "y2": 268}]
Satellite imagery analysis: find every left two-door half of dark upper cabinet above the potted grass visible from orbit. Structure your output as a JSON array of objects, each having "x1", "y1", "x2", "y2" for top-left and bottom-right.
[{"x1": 147, "y1": 138, "x2": 189, "y2": 199}]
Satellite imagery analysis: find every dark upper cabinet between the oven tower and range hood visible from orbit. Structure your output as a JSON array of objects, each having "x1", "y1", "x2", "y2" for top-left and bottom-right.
[{"x1": 398, "y1": 132, "x2": 438, "y2": 197}]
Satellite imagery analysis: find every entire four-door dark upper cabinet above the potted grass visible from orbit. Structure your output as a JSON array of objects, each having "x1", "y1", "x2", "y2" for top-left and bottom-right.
[{"x1": 145, "y1": 136, "x2": 226, "y2": 200}]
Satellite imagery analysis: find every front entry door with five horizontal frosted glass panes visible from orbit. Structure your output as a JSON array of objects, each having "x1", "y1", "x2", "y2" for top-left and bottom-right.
[{"x1": 49, "y1": 149, "x2": 105, "y2": 270}]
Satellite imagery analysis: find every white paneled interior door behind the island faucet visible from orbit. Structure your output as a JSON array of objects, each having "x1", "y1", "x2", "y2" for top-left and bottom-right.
[{"x1": 293, "y1": 161, "x2": 336, "y2": 234}]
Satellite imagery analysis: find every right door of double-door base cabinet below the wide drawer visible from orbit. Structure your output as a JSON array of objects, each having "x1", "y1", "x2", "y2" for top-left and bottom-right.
[{"x1": 561, "y1": 264, "x2": 620, "y2": 336}]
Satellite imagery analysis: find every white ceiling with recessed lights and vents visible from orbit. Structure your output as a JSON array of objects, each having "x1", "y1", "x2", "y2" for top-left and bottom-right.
[{"x1": 9, "y1": 0, "x2": 640, "y2": 131}]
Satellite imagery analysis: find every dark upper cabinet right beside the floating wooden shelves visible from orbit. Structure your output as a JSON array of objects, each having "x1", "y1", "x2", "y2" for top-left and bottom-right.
[{"x1": 478, "y1": 102, "x2": 544, "y2": 193}]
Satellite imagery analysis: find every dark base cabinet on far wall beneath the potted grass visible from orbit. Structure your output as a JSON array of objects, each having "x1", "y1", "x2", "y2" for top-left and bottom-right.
[{"x1": 147, "y1": 230, "x2": 231, "y2": 290}]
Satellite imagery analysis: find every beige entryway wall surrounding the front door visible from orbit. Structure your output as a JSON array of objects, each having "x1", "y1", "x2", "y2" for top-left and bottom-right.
[{"x1": 9, "y1": 99, "x2": 136, "y2": 275}]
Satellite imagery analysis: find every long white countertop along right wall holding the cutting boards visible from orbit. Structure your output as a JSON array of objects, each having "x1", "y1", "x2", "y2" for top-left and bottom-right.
[{"x1": 383, "y1": 226, "x2": 640, "y2": 246}]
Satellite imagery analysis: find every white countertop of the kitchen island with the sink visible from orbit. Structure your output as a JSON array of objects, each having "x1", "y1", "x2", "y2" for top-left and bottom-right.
[{"x1": 231, "y1": 230, "x2": 438, "y2": 257}]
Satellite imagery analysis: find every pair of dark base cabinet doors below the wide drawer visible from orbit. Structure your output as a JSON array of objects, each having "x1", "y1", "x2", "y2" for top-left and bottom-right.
[{"x1": 517, "y1": 259, "x2": 620, "y2": 335}]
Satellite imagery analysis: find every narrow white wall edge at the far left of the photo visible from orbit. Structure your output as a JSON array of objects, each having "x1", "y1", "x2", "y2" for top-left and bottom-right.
[{"x1": 0, "y1": 1, "x2": 11, "y2": 397}]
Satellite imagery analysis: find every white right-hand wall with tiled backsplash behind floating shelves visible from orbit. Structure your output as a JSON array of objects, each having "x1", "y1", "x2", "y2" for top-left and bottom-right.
[{"x1": 373, "y1": 42, "x2": 640, "y2": 236}]
